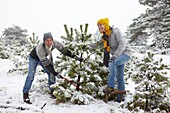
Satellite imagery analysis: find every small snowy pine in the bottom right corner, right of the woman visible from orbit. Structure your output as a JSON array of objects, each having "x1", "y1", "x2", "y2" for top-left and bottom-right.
[{"x1": 127, "y1": 52, "x2": 170, "y2": 113}]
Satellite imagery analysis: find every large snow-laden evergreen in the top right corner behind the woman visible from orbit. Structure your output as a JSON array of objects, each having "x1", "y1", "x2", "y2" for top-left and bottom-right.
[{"x1": 128, "y1": 0, "x2": 170, "y2": 51}]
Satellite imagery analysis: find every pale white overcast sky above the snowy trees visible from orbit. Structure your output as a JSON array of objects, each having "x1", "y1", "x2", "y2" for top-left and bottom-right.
[{"x1": 0, "y1": 0, "x2": 146, "y2": 38}]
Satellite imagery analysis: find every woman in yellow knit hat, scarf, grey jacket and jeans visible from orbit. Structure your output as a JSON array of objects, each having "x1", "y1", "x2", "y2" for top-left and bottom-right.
[{"x1": 97, "y1": 18, "x2": 132, "y2": 102}]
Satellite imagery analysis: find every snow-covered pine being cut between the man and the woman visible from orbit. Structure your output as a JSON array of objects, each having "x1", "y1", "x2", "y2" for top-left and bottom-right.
[{"x1": 52, "y1": 24, "x2": 107, "y2": 104}]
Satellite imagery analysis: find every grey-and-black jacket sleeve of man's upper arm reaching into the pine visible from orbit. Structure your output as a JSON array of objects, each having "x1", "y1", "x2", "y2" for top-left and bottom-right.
[{"x1": 54, "y1": 40, "x2": 75, "y2": 58}]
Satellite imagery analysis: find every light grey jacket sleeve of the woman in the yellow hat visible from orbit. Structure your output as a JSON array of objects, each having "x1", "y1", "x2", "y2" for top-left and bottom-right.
[{"x1": 114, "y1": 28, "x2": 126, "y2": 58}]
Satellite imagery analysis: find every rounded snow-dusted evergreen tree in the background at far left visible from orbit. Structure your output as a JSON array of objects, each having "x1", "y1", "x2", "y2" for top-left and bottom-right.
[{"x1": 2, "y1": 25, "x2": 27, "y2": 59}]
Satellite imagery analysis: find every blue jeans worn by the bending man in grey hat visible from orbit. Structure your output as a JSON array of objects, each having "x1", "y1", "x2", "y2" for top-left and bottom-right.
[{"x1": 23, "y1": 56, "x2": 56, "y2": 93}]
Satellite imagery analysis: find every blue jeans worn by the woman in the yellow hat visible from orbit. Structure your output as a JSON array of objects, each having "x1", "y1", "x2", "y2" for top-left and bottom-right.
[{"x1": 108, "y1": 54, "x2": 130, "y2": 101}]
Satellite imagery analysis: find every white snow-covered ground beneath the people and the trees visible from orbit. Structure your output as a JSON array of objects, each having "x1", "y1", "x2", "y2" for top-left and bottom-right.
[{"x1": 0, "y1": 56, "x2": 170, "y2": 113}]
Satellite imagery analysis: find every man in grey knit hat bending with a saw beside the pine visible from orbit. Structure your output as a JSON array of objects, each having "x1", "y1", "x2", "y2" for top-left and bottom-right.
[{"x1": 23, "y1": 32, "x2": 83, "y2": 104}]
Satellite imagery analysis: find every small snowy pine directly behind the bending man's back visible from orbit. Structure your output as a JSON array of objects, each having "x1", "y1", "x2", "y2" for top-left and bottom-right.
[{"x1": 9, "y1": 33, "x2": 40, "y2": 74}]
